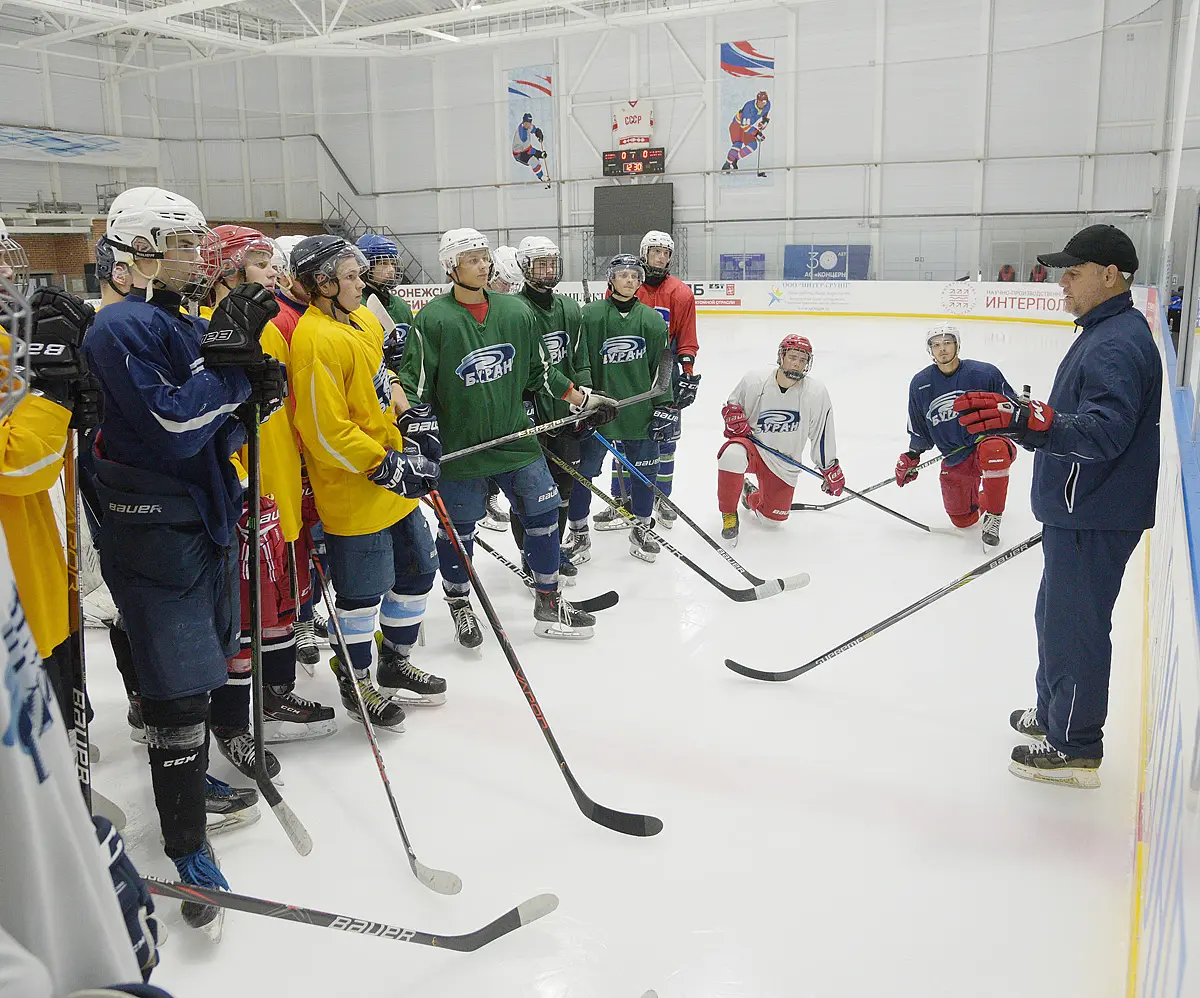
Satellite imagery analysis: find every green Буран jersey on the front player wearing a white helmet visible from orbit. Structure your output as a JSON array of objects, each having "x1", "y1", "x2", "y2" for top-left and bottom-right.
[{"x1": 400, "y1": 291, "x2": 571, "y2": 481}]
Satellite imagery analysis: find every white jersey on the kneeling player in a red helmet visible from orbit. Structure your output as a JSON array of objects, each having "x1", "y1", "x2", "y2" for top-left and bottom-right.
[{"x1": 728, "y1": 367, "x2": 838, "y2": 485}]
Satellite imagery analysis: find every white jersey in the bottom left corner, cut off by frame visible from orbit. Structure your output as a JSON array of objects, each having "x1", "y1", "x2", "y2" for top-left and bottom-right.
[{"x1": 0, "y1": 531, "x2": 142, "y2": 998}]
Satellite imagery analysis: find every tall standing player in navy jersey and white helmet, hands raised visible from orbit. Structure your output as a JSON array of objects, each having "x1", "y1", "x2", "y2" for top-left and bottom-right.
[{"x1": 84, "y1": 187, "x2": 282, "y2": 926}]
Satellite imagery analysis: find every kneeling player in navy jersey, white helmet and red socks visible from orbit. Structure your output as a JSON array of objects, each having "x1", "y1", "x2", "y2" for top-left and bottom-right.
[{"x1": 896, "y1": 323, "x2": 1016, "y2": 551}]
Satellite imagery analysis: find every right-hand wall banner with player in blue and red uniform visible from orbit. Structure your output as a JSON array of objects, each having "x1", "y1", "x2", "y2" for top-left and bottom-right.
[{"x1": 714, "y1": 38, "x2": 779, "y2": 180}]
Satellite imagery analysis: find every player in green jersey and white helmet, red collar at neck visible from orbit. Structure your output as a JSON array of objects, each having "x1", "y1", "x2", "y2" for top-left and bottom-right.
[{"x1": 401, "y1": 229, "x2": 613, "y2": 648}]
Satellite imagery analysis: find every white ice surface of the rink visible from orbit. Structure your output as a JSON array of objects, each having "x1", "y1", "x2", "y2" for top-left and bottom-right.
[{"x1": 88, "y1": 317, "x2": 1145, "y2": 998}]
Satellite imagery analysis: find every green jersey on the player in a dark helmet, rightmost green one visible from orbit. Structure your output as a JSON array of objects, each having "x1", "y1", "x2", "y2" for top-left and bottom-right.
[{"x1": 577, "y1": 297, "x2": 671, "y2": 440}]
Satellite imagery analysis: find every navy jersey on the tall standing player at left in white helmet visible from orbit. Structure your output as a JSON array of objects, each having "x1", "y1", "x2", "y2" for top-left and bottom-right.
[{"x1": 83, "y1": 290, "x2": 250, "y2": 547}]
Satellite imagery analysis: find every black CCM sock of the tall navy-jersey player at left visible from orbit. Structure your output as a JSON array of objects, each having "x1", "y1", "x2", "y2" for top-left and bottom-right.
[{"x1": 142, "y1": 693, "x2": 209, "y2": 859}]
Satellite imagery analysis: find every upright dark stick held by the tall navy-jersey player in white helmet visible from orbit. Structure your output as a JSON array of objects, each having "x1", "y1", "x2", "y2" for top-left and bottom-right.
[{"x1": 246, "y1": 402, "x2": 312, "y2": 856}]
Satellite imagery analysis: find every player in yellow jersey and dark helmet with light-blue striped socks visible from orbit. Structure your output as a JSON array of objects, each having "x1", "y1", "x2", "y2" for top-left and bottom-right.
[{"x1": 292, "y1": 235, "x2": 446, "y2": 731}]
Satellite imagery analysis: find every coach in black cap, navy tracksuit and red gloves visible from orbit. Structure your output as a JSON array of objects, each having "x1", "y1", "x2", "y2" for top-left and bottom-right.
[{"x1": 954, "y1": 226, "x2": 1163, "y2": 787}]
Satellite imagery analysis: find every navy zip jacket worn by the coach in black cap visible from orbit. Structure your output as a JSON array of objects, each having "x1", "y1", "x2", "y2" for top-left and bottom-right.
[{"x1": 1032, "y1": 294, "x2": 1163, "y2": 530}]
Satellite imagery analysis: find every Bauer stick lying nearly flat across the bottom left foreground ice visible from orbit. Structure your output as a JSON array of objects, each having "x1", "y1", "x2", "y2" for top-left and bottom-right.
[{"x1": 142, "y1": 877, "x2": 558, "y2": 952}]
